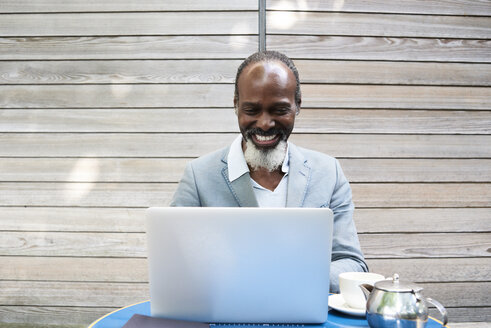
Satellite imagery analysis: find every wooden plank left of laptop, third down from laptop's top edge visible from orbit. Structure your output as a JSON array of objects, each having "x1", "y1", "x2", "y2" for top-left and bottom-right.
[{"x1": 0, "y1": 256, "x2": 148, "y2": 282}]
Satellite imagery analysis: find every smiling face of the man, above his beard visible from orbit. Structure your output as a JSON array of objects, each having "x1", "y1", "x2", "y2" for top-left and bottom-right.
[{"x1": 235, "y1": 61, "x2": 297, "y2": 150}]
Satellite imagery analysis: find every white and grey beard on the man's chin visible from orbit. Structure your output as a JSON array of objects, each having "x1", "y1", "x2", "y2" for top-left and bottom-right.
[{"x1": 244, "y1": 138, "x2": 287, "y2": 172}]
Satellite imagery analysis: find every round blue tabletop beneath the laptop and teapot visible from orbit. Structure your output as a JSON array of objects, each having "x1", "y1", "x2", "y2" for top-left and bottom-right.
[{"x1": 89, "y1": 301, "x2": 450, "y2": 328}]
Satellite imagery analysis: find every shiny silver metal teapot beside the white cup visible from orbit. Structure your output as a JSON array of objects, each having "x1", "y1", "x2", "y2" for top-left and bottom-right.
[{"x1": 360, "y1": 274, "x2": 448, "y2": 328}]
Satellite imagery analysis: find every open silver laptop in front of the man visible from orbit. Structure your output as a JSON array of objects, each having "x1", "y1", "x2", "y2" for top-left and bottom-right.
[{"x1": 146, "y1": 207, "x2": 333, "y2": 323}]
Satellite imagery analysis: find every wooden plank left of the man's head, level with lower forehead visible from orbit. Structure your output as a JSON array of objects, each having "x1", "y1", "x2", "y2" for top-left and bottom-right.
[{"x1": 0, "y1": 84, "x2": 234, "y2": 108}]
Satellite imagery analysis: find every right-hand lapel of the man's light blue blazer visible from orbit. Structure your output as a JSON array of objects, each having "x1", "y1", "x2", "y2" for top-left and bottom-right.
[{"x1": 286, "y1": 143, "x2": 311, "y2": 207}]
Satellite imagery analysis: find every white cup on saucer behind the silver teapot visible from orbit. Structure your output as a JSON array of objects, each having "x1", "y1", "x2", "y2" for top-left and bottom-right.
[{"x1": 339, "y1": 272, "x2": 385, "y2": 309}]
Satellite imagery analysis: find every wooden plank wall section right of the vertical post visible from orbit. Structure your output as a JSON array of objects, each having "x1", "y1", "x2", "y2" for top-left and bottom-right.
[{"x1": 266, "y1": 0, "x2": 491, "y2": 322}]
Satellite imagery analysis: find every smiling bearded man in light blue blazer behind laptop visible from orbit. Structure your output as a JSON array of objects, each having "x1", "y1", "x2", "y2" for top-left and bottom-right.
[{"x1": 171, "y1": 51, "x2": 367, "y2": 292}]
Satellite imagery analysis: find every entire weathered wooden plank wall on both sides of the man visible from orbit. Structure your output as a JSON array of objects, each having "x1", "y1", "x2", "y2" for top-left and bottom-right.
[{"x1": 0, "y1": 0, "x2": 491, "y2": 325}]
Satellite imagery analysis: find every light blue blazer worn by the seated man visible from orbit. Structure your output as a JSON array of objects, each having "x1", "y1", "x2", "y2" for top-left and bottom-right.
[{"x1": 171, "y1": 143, "x2": 368, "y2": 292}]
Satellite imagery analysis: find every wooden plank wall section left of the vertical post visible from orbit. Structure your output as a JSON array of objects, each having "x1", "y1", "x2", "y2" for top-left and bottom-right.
[{"x1": 0, "y1": 0, "x2": 258, "y2": 326}]
